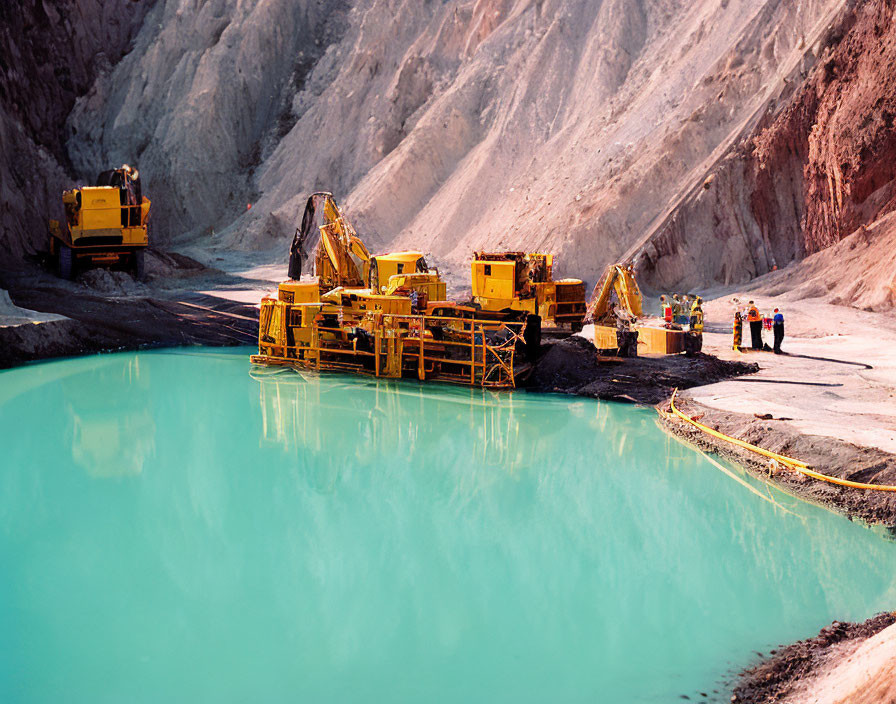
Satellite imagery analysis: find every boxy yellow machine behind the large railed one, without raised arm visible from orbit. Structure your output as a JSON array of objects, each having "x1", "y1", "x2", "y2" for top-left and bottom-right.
[{"x1": 471, "y1": 252, "x2": 585, "y2": 332}]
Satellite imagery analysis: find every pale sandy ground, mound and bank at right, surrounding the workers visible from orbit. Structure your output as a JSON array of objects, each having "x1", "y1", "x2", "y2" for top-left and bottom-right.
[{"x1": 656, "y1": 214, "x2": 896, "y2": 528}]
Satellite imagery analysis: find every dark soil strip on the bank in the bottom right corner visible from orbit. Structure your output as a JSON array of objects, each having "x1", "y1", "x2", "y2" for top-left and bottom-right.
[{"x1": 731, "y1": 614, "x2": 896, "y2": 704}]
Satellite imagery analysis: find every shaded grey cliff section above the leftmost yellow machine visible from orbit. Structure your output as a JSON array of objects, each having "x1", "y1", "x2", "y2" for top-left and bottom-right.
[{"x1": 67, "y1": 0, "x2": 345, "y2": 240}]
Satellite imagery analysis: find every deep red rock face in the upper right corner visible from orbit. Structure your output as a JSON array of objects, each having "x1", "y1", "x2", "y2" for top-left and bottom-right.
[{"x1": 751, "y1": 0, "x2": 896, "y2": 254}]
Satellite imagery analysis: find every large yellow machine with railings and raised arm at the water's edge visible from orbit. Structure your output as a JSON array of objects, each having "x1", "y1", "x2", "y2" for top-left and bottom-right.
[{"x1": 252, "y1": 193, "x2": 527, "y2": 388}]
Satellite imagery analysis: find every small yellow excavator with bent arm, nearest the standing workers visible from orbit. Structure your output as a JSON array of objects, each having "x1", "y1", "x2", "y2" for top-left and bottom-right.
[{"x1": 588, "y1": 264, "x2": 703, "y2": 357}]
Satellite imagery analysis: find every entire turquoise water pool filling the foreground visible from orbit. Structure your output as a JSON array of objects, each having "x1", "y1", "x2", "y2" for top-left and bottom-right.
[{"x1": 0, "y1": 350, "x2": 896, "y2": 702}]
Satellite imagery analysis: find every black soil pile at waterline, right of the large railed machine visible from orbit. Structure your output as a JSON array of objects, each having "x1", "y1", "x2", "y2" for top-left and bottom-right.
[{"x1": 526, "y1": 335, "x2": 759, "y2": 405}]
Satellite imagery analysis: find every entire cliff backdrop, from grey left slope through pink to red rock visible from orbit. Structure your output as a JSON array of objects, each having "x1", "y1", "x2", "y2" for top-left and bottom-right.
[{"x1": 5, "y1": 0, "x2": 893, "y2": 308}]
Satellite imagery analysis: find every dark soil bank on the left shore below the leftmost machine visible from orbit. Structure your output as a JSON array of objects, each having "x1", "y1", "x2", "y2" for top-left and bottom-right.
[{"x1": 0, "y1": 258, "x2": 258, "y2": 369}]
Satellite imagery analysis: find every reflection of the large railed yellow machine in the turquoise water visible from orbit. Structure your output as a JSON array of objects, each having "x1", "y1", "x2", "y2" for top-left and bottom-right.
[{"x1": 253, "y1": 371, "x2": 580, "y2": 474}]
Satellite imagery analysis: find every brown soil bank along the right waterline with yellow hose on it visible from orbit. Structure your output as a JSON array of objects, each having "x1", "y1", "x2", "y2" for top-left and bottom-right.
[{"x1": 659, "y1": 398, "x2": 896, "y2": 524}]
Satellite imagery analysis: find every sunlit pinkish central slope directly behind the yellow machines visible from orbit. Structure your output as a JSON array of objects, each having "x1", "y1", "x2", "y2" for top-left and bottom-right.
[{"x1": 229, "y1": 0, "x2": 839, "y2": 280}]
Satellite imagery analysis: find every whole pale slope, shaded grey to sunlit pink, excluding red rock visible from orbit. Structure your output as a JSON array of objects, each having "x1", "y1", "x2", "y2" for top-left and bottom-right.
[{"x1": 57, "y1": 0, "x2": 844, "y2": 279}]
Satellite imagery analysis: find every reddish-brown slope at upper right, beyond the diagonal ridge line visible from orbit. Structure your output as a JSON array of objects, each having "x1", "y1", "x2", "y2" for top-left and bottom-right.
[{"x1": 640, "y1": 0, "x2": 896, "y2": 296}]
